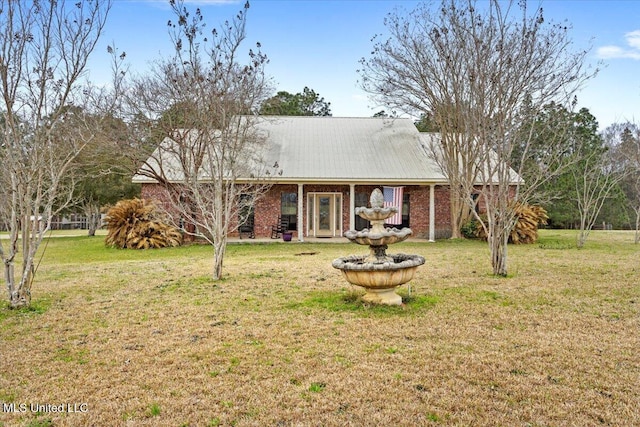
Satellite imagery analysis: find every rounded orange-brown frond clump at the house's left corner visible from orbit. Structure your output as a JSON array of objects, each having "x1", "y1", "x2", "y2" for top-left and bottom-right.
[{"x1": 105, "y1": 198, "x2": 182, "y2": 249}]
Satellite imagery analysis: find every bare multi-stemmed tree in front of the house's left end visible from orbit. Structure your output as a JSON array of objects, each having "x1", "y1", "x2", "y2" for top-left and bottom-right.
[{"x1": 131, "y1": 1, "x2": 271, "y2": 279}]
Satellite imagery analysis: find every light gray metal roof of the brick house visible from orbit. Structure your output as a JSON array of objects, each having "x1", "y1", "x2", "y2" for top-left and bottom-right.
[{"x1": 133, "y1": 116, "x2": 447, "y2": 184}]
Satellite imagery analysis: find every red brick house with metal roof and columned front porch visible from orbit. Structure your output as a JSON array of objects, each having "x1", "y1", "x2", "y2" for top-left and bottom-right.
[{"x1": 134, "y1": 116, "x2": 458, "y2": 241}]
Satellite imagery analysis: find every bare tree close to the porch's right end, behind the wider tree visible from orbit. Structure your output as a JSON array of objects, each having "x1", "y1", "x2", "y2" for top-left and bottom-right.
[{"x1": 359, "y1": 2, "x2": 479, "y2": 238}]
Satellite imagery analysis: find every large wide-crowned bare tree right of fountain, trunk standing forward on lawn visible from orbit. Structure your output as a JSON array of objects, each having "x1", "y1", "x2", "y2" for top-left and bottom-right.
[{"x1": 361, "y1": 0, "x2": 590, "y2": 275}]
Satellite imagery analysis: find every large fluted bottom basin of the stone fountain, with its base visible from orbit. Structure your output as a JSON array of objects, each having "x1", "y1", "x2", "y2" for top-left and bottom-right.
[{"x1": 331, "y1": 254, "x2": 425, "y2": 305}]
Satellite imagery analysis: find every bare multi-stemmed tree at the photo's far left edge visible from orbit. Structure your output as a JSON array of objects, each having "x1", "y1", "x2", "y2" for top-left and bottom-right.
[{"x1": 0, "y1": 0, "x2": 110, "y2": 307}]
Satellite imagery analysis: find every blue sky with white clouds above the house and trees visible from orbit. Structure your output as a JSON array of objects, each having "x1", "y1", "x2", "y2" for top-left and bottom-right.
[{"x1": 94, "y1": 0, "x2": 640, "y2": 130}]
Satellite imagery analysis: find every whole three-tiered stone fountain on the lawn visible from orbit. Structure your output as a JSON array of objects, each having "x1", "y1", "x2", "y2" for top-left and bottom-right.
[{"x1": 332, "y1": 188, "x2": 425, "y2": 305}]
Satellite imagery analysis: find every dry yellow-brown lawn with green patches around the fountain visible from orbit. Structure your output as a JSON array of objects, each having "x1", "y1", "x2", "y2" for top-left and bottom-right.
[{"x1": 0, "y1": 231, "x2": 640, "y2": 427}]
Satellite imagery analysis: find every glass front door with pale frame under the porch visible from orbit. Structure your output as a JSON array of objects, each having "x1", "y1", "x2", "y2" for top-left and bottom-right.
[{"x1": 307, "y1": 193, "x2": 342, "y2": 237}]
